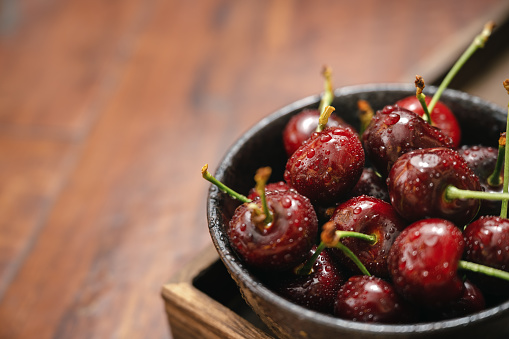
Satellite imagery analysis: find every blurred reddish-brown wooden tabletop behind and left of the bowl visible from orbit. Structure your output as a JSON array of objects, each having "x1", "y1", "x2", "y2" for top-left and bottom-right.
[{"x1": 0, "y1": 0, "x2": 509, "y2": 339}]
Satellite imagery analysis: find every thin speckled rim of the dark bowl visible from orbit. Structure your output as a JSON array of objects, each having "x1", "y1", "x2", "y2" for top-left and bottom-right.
[{"x1": 207, "y1": 83, "x2": 509, "y2": 335}]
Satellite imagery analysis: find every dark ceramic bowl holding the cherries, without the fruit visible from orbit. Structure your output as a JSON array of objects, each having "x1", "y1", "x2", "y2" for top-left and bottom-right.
[{"x1": 207, "y1": 84, "x2": 509, "y2": 338}]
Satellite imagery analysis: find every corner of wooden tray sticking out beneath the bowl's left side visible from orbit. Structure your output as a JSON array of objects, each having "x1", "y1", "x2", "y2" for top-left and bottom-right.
[{"x1": 162, "y1": 246, "x2": 274, "y2": 339}]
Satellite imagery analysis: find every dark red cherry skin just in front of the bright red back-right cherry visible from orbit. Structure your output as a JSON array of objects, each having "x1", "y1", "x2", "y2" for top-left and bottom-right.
[{"x1": 362, "y1": 106, "x2": 452, "y2": 177}]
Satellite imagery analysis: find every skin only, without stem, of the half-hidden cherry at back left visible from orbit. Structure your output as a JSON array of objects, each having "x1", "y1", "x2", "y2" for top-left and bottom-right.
[{"x1": 283, "y1": 109, "x2": 353, "y2": 157}]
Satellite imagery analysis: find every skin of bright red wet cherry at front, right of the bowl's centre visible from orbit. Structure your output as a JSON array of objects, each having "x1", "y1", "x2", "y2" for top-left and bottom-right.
[{"x1": 388, "y1": 219, "x2": 465, "y2": 308}]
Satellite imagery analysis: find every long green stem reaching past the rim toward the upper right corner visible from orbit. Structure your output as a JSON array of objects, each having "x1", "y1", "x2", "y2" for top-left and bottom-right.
[{"x1": 428, "y1": 21, "x2": 495, "y2": 112}]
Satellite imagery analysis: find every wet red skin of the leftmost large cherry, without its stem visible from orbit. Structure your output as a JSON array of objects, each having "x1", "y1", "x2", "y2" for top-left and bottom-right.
[{"x1": 227, "y1": 190, "x2": 318, "y2": 270}]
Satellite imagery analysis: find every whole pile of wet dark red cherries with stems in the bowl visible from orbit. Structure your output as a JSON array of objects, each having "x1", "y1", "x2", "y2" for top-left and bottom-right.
[{"x1": 202, "y1": 22, "x2": 509, "y2": 323}]
